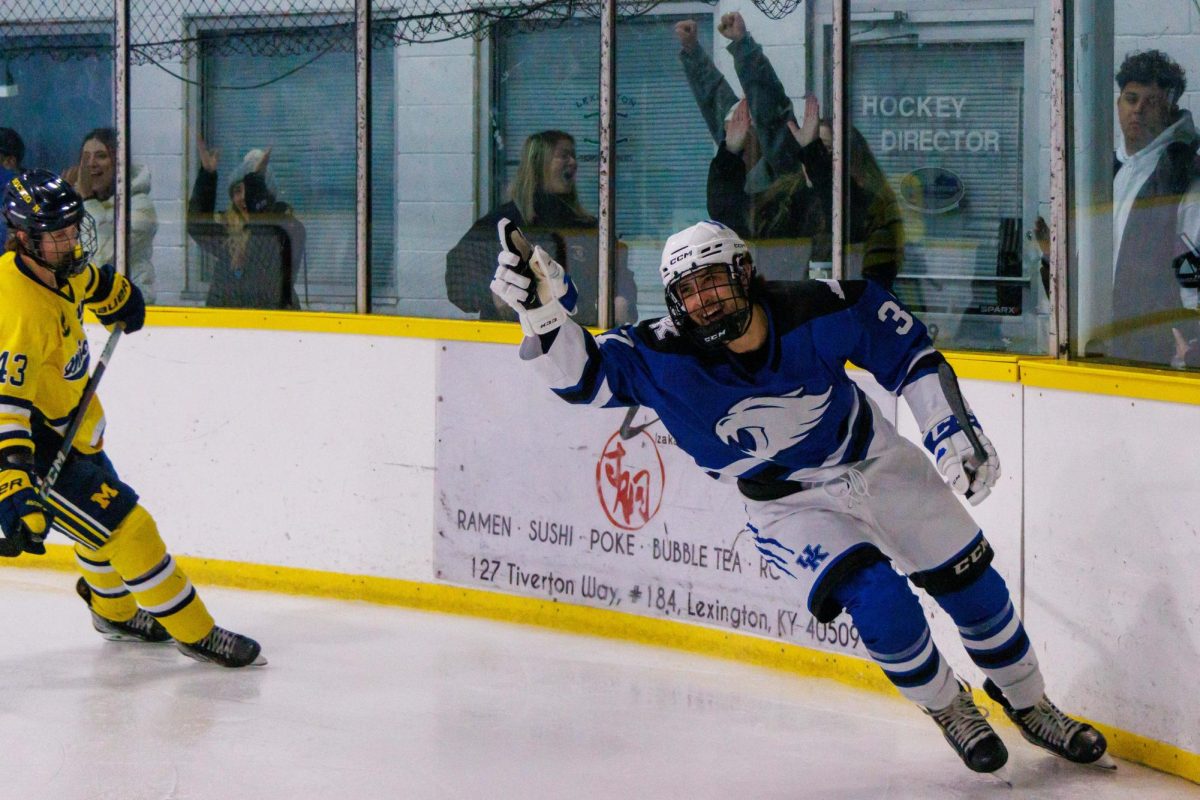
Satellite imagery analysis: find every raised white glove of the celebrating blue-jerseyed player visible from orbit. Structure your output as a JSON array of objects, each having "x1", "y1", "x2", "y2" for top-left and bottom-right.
[{"x1": 491, "y1": 219, "x2": 578, "y2": 336}]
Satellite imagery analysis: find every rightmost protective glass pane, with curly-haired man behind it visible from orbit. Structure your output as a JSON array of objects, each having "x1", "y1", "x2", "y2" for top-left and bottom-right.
[{"x1": 1070, "y1": 0, "x2": 1200, "y2": 369}]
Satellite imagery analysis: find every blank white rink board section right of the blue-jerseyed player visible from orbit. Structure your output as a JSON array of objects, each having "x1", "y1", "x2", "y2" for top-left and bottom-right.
[{"x1": 1025, "y1": 389, "x2": 1200, "y2": 752}]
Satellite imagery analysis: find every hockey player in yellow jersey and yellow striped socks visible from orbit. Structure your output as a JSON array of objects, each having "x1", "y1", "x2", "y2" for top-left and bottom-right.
[{"x1": 0, "y1": 169, "x2": 266, "y2": 667}]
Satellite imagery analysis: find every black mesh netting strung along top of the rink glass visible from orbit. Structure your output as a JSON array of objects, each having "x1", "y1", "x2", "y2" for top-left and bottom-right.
[{"x1": 0, "y1": 0, "x2": 802, "y2": 64}]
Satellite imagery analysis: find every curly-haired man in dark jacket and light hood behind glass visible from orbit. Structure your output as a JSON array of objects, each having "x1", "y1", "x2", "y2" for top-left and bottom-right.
[{"x1": 1106, "y1": 50, "x2": 1200, "y2": 367}]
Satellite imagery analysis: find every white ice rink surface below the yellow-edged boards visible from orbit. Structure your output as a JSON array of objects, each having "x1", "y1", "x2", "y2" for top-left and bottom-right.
[{"x1": 0, "y1": 570, "x2": 1200, "y2": 800}]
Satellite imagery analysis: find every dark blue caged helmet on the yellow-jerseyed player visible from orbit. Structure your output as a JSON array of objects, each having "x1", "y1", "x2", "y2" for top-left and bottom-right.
[{"x1": 0, "y1": 169, "x2": 96, "y2": 281}]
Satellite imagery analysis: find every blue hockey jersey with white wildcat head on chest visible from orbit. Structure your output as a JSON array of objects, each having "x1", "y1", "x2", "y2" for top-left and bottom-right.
[{"x1": 532, "y1": 281, "x2": 943, "y2": 491}]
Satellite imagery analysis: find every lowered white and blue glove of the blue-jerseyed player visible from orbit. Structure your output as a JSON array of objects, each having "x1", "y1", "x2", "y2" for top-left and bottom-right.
[{"x1": 902, "y1": 365, "x2": 1000, "y2": 505}]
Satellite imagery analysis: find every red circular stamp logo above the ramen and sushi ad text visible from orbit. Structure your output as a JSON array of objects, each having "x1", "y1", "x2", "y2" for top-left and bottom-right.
[{"x1": 596, "y1": 431, "x2": 666, "y2": 530}]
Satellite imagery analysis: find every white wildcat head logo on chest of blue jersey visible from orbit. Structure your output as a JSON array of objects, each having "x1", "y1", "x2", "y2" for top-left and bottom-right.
[{"x1": 715, "y1": 386, "x2": 833, "y2": 458}]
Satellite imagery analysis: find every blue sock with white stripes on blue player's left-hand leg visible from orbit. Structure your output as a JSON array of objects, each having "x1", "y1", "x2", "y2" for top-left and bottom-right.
[{"x1": 833, "y1": 561, "x2": 958, "y2": 709}]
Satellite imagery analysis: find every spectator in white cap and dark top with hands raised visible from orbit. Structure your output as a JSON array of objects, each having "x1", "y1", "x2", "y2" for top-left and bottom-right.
[{"x1": 187, "y1": 137, "x2": 305, "y2": 309}]
